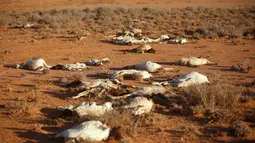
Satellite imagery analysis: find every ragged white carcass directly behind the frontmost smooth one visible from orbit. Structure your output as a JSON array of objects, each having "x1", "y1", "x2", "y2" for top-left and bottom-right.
[{"x1": 60, "y1": 102, "x2": 113, "y2": 117}]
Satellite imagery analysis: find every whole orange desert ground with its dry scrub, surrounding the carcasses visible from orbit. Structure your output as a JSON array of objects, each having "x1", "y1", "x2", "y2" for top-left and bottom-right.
[{"x1": 0, "y1": 0, "x2": 255, "y2": 143}]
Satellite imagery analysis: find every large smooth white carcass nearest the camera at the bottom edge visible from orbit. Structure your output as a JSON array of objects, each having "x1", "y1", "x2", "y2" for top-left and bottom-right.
[{"x1": 54, "y1": 121, "x2": 110, "y2": 142}]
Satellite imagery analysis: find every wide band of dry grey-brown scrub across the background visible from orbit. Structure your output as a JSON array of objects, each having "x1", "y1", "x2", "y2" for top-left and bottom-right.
[{"x1": 0, "y1": 6, "x2": 255, "y2": 39}]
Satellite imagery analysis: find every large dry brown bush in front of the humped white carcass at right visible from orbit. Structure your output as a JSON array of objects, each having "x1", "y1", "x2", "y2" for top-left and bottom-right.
[{"x1": 183, "y1": 83, "x2": 241, "y2": 121}]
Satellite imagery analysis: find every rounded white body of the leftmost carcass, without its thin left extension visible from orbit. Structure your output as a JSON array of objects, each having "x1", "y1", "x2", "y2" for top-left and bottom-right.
[{"x1": 19, "y1": 58, "x2": 51, "y2": 70}]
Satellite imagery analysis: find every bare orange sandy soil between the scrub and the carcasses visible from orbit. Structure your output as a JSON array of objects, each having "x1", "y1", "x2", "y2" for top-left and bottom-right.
[{"x1": 0, "y1": 0, "x2": 255, "y2": 143}]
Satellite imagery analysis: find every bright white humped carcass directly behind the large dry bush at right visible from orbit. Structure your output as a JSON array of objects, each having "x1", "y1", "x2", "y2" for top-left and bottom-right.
[{"x1": 153, "y1": 72, "x2": 210, "y2": 87}]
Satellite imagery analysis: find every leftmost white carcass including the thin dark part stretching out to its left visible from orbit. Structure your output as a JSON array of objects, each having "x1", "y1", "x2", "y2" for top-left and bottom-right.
[{"x1": 4, "y1": 58, "x2": 51, "y2": 71}]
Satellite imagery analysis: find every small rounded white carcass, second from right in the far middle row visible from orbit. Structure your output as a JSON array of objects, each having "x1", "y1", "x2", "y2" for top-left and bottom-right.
[{"x1": 135, "y1": 61, "x2": 161, "y2": 72}]
